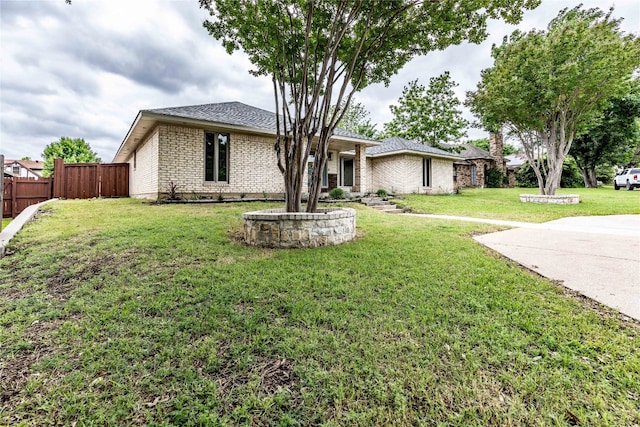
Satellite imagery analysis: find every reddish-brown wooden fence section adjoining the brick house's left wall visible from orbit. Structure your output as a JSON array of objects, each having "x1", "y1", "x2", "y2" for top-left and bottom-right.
[{"x1": 53, "y1": 159, "x2": 129, "y2": 199}]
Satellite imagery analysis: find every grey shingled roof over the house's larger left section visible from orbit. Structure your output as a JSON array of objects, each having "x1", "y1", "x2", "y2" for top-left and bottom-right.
[{"x1": 142, "y1": 102, "x2": 376, "y2": 141}]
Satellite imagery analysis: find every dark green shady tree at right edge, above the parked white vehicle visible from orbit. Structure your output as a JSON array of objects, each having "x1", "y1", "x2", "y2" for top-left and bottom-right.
[{"x1": 569, "y1": 81, "x2": 640, "y2": 188}]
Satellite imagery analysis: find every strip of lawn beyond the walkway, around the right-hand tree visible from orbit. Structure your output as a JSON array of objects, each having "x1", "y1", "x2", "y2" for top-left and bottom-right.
[{"x1": 399, "y1": 187, "x2": 640, "y2": 222}]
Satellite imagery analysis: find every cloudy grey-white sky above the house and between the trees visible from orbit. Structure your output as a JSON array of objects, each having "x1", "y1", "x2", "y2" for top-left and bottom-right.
[{"x1": 0, "y1": 0, "x2": 640, "y2": 162}]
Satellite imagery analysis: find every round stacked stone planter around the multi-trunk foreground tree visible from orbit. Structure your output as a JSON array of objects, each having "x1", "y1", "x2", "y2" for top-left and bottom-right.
[{"x1": 243, "y1": 208, "x2": 356, "y2": 248}]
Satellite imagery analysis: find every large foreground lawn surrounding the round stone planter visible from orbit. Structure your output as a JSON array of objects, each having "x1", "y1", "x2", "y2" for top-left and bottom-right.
[{"x1": 0, "y1": 199, "x2": 640, "y2": 426}]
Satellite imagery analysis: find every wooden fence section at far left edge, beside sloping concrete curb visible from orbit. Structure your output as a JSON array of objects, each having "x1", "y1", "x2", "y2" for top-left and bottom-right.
[{"x1": 2, "y1": 177, "x2": 53, "y2": 218}]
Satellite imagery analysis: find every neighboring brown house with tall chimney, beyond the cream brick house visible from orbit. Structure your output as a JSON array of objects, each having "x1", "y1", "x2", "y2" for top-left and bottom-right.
[{"x1": 447, "y1": 133, "x2": 508, "y2": 188}]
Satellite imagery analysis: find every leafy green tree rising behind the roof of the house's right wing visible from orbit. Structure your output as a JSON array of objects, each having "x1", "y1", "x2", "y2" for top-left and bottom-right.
[{"x1": 384, "y1": 71, "x2": 469, "y2": 146}]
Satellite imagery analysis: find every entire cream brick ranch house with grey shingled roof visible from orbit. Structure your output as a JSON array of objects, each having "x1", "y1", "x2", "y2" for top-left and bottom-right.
[{"x1": 113, "y1": 102, "x2": 461, "y2": 200}]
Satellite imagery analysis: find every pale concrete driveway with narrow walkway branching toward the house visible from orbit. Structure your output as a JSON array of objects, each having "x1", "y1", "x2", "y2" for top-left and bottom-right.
[{"x1": 409, "y1": 214, "x2": 640, "y2": 320}]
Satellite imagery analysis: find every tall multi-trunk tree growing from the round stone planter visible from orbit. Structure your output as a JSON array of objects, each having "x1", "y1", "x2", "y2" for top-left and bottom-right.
[{"x1": 199, "y1": 0, "x2": 539, "y2": 212}]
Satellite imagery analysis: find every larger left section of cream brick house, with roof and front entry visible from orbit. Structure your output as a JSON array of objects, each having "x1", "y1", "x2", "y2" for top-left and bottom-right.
[{"x1": 114, "y1": 102, "x2": 380, "y2": 199}]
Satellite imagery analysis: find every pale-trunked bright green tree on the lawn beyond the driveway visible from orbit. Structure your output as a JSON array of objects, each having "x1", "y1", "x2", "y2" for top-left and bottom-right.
[{"x1": 467, "y1": 6, "x2": 640, "y2": 195}]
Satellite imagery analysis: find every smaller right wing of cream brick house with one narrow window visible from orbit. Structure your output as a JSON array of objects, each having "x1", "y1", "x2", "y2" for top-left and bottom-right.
[{"x1": 367, "y1": 137, "x2": 462, "y2": 194}]
